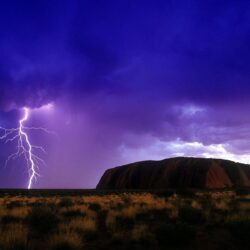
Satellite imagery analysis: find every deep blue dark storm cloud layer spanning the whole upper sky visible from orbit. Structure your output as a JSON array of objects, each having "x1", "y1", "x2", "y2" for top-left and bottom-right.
[{"x1": 0, "y1": 1, "x2": 250, "y2": 106}]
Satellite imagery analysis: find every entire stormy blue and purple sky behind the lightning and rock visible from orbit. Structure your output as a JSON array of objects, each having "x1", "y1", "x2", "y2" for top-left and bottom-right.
[{"x1": 0, "y1": 0, "x2": 250, "y2": 188}]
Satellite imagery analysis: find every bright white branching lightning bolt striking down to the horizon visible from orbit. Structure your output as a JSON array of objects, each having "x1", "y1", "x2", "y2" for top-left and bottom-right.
[{"x1": 0, "y1": 107, "x2": 54, "y2": 189}]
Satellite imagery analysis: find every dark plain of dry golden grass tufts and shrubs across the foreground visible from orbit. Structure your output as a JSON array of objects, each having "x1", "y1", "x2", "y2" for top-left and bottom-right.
[{"x1": 0, "y1": 191, "x2": 250, "y2": 250}]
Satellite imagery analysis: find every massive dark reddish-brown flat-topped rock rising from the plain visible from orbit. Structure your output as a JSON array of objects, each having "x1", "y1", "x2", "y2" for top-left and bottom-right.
[{"x1": 97, "y1": 157, "x2": 250, "y2": 189}]
